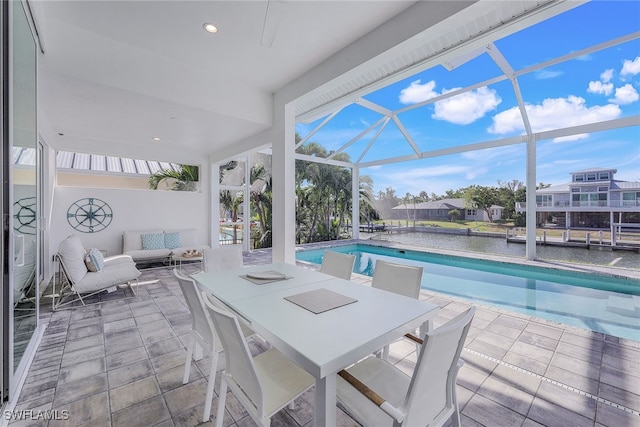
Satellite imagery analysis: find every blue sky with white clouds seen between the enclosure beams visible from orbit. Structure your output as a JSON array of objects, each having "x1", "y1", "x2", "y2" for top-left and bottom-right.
[{"x1": 296, "y1": 1, "x2": 640, "y2": 196}]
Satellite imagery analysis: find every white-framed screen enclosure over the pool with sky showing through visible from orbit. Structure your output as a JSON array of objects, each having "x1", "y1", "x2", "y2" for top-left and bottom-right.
[{"x1": 216, "y1": 2, "x2": 640, "y2": 259}]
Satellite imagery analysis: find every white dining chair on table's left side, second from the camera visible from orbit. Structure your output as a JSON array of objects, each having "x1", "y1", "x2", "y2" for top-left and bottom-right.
[{"x1": 173, "y1": 269, "x2": 254, "y2": 422}]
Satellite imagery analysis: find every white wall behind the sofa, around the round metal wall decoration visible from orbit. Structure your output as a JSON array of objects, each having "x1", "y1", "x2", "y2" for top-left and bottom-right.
[{"x1": 49, "y1": 186, "x2": 210, "y2": 264}]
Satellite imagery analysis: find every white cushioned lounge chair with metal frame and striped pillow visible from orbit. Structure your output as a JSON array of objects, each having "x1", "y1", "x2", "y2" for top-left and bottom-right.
[{"x1": 53, "y1": 234, "x2": 142, "y2": 310}]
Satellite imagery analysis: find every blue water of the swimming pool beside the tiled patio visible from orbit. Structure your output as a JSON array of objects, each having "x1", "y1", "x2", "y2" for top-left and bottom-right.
[{"x1": 296, "y1": 244, "x2": 640, "y2": 341}]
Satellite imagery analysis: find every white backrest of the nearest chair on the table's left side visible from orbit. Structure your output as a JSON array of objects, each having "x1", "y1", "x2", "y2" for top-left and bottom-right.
[{"x1": 202, "y1": 293, "x2": 263, "y2": 414}]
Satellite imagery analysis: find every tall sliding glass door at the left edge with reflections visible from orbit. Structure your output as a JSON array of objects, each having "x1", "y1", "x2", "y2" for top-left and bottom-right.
[{"x1": 0, "y1": 1, "x2": 40, "y2": 408}]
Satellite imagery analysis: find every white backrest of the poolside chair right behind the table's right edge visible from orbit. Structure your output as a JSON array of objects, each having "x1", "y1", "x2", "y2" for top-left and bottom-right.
[{"x1": 371, "y1": 260, "x2": 422, "y2": 299}]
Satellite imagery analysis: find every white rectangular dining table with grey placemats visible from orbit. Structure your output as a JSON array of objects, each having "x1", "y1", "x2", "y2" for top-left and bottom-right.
[{"x1": 191, "y1": 264, "x2": 438, "y2": 426}]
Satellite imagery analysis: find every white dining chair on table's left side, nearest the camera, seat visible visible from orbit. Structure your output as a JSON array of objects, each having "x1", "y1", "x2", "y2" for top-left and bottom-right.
[{"x1": 203, "y1": 294, "x2": 315, "y2": 427}]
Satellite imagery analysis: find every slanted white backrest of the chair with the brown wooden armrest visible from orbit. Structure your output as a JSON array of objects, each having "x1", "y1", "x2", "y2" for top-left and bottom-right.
[{"x1": 402, "y1": 307, "x2": 475, "y2": 426}]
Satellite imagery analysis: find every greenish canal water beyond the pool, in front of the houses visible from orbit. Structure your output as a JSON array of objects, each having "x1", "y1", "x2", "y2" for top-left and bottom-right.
[{"x1": 370, "y1": 232, "x2": 640, "y2": 270}]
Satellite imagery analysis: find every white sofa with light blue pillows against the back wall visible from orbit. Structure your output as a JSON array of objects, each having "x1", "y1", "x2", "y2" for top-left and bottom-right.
[{"x1": 122, "y1": 229, "x2": 208, "y2": 262}]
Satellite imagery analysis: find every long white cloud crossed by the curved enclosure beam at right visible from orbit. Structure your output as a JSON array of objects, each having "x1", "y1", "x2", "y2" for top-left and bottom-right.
[{"x1": 487, "y1": 96, "x2": 622, "y2": 140}]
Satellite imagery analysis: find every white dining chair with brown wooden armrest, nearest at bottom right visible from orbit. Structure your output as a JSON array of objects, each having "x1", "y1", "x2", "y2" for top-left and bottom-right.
[{"x1": 337, "y1": 307, "x2": 475, "y2": 427}]
